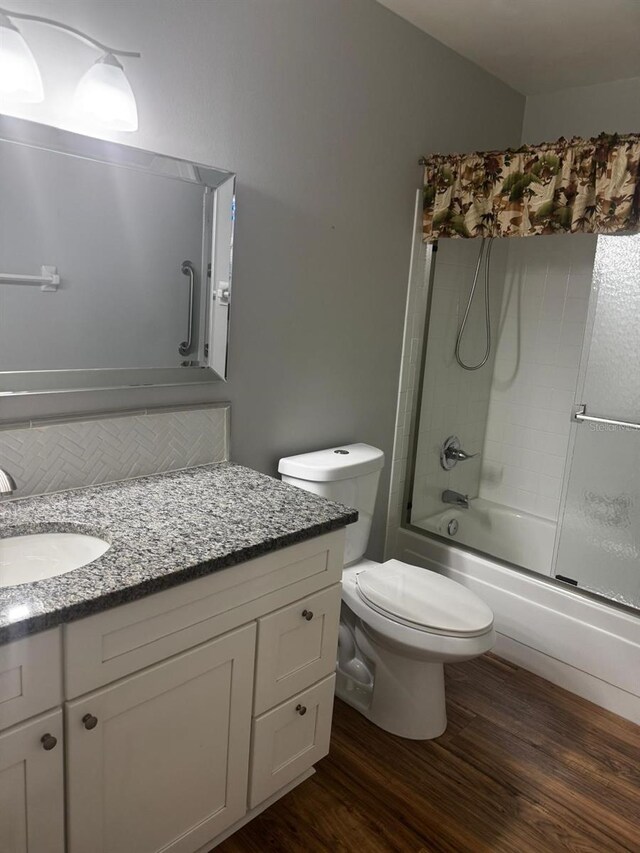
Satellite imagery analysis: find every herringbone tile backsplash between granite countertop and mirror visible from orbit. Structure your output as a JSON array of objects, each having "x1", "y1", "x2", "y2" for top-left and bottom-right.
[{"x1": 0, "y1": 406, "x2": 229, "y2": 497}]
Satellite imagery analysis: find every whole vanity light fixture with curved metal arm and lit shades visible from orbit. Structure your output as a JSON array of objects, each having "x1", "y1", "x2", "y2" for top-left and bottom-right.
[{"x1": 0, "y1": 8, "x2": 140, "y2": 131}]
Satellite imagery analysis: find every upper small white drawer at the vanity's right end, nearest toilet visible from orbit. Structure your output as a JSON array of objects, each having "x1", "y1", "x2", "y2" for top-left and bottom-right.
[{"x1": 254, "y1": 584, "x2": 342, "y2": 715}]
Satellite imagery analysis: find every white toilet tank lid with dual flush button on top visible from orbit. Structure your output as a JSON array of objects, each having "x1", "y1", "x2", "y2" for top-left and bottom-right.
[{"x1": 278, "y1": 444, "x2": 384, "y2": 483}]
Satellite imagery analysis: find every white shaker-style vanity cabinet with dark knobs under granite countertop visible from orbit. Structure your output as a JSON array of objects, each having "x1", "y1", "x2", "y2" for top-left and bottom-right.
[{"x1": 0, "y1": 529, "x2": 344, "y2": 853}]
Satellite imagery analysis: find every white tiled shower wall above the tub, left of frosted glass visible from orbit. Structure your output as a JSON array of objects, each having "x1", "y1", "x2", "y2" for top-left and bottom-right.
[{"x1": 385, "y1": 233, "x2": 596, "y2": 558}]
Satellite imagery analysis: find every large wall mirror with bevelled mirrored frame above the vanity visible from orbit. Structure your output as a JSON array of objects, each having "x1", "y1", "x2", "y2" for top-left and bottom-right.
[{"x1": 0, "y1": 116, "x2": 235, "y2": 395}]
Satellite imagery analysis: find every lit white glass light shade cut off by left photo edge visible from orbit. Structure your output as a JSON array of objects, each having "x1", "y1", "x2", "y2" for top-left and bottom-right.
[{"x1": 0, "y1": 13, "x2": 44, "y2": 104}]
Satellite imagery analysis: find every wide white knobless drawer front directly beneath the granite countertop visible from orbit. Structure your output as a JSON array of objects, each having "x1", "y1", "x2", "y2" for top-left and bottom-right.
[{"x1": 65, "y1": 529, "x2": 344, "y2": 699}]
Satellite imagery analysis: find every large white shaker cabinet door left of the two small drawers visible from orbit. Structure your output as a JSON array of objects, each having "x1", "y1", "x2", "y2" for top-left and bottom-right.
[{"x1": 66, "y1": 624, "x2": 255, "y2": 853}]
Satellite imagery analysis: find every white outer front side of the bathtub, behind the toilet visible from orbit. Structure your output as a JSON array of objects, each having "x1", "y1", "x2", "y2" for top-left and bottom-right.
[{"x1": 397, "y1": 530, "x2": 640, "y2": 723}]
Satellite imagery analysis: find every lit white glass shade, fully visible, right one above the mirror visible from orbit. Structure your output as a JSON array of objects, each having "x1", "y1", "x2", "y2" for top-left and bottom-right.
[{"x1": 74, "y1": 53, "x2": 138, "y2": 131}]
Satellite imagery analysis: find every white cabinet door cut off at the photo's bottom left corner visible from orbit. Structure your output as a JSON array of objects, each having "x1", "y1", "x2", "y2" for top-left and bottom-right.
[{"x1": 0, "y1": 710, "x2": 64, "y2": 853}]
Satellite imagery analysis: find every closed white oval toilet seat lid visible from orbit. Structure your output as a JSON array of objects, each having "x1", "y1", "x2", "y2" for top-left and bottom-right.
[{"x1": 355, "y1": 560, "x2": 493, "y2": 638}]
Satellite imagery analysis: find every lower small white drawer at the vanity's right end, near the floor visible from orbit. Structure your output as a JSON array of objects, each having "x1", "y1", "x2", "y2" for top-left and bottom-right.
[{"x1": 249, "y1": 674, "x2": 336, "y2": 808}]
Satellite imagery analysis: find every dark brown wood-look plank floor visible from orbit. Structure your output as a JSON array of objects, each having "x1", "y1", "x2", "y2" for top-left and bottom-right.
[{"x1": 215, "y1": 655, "x2": 640, "y2": 853}]
